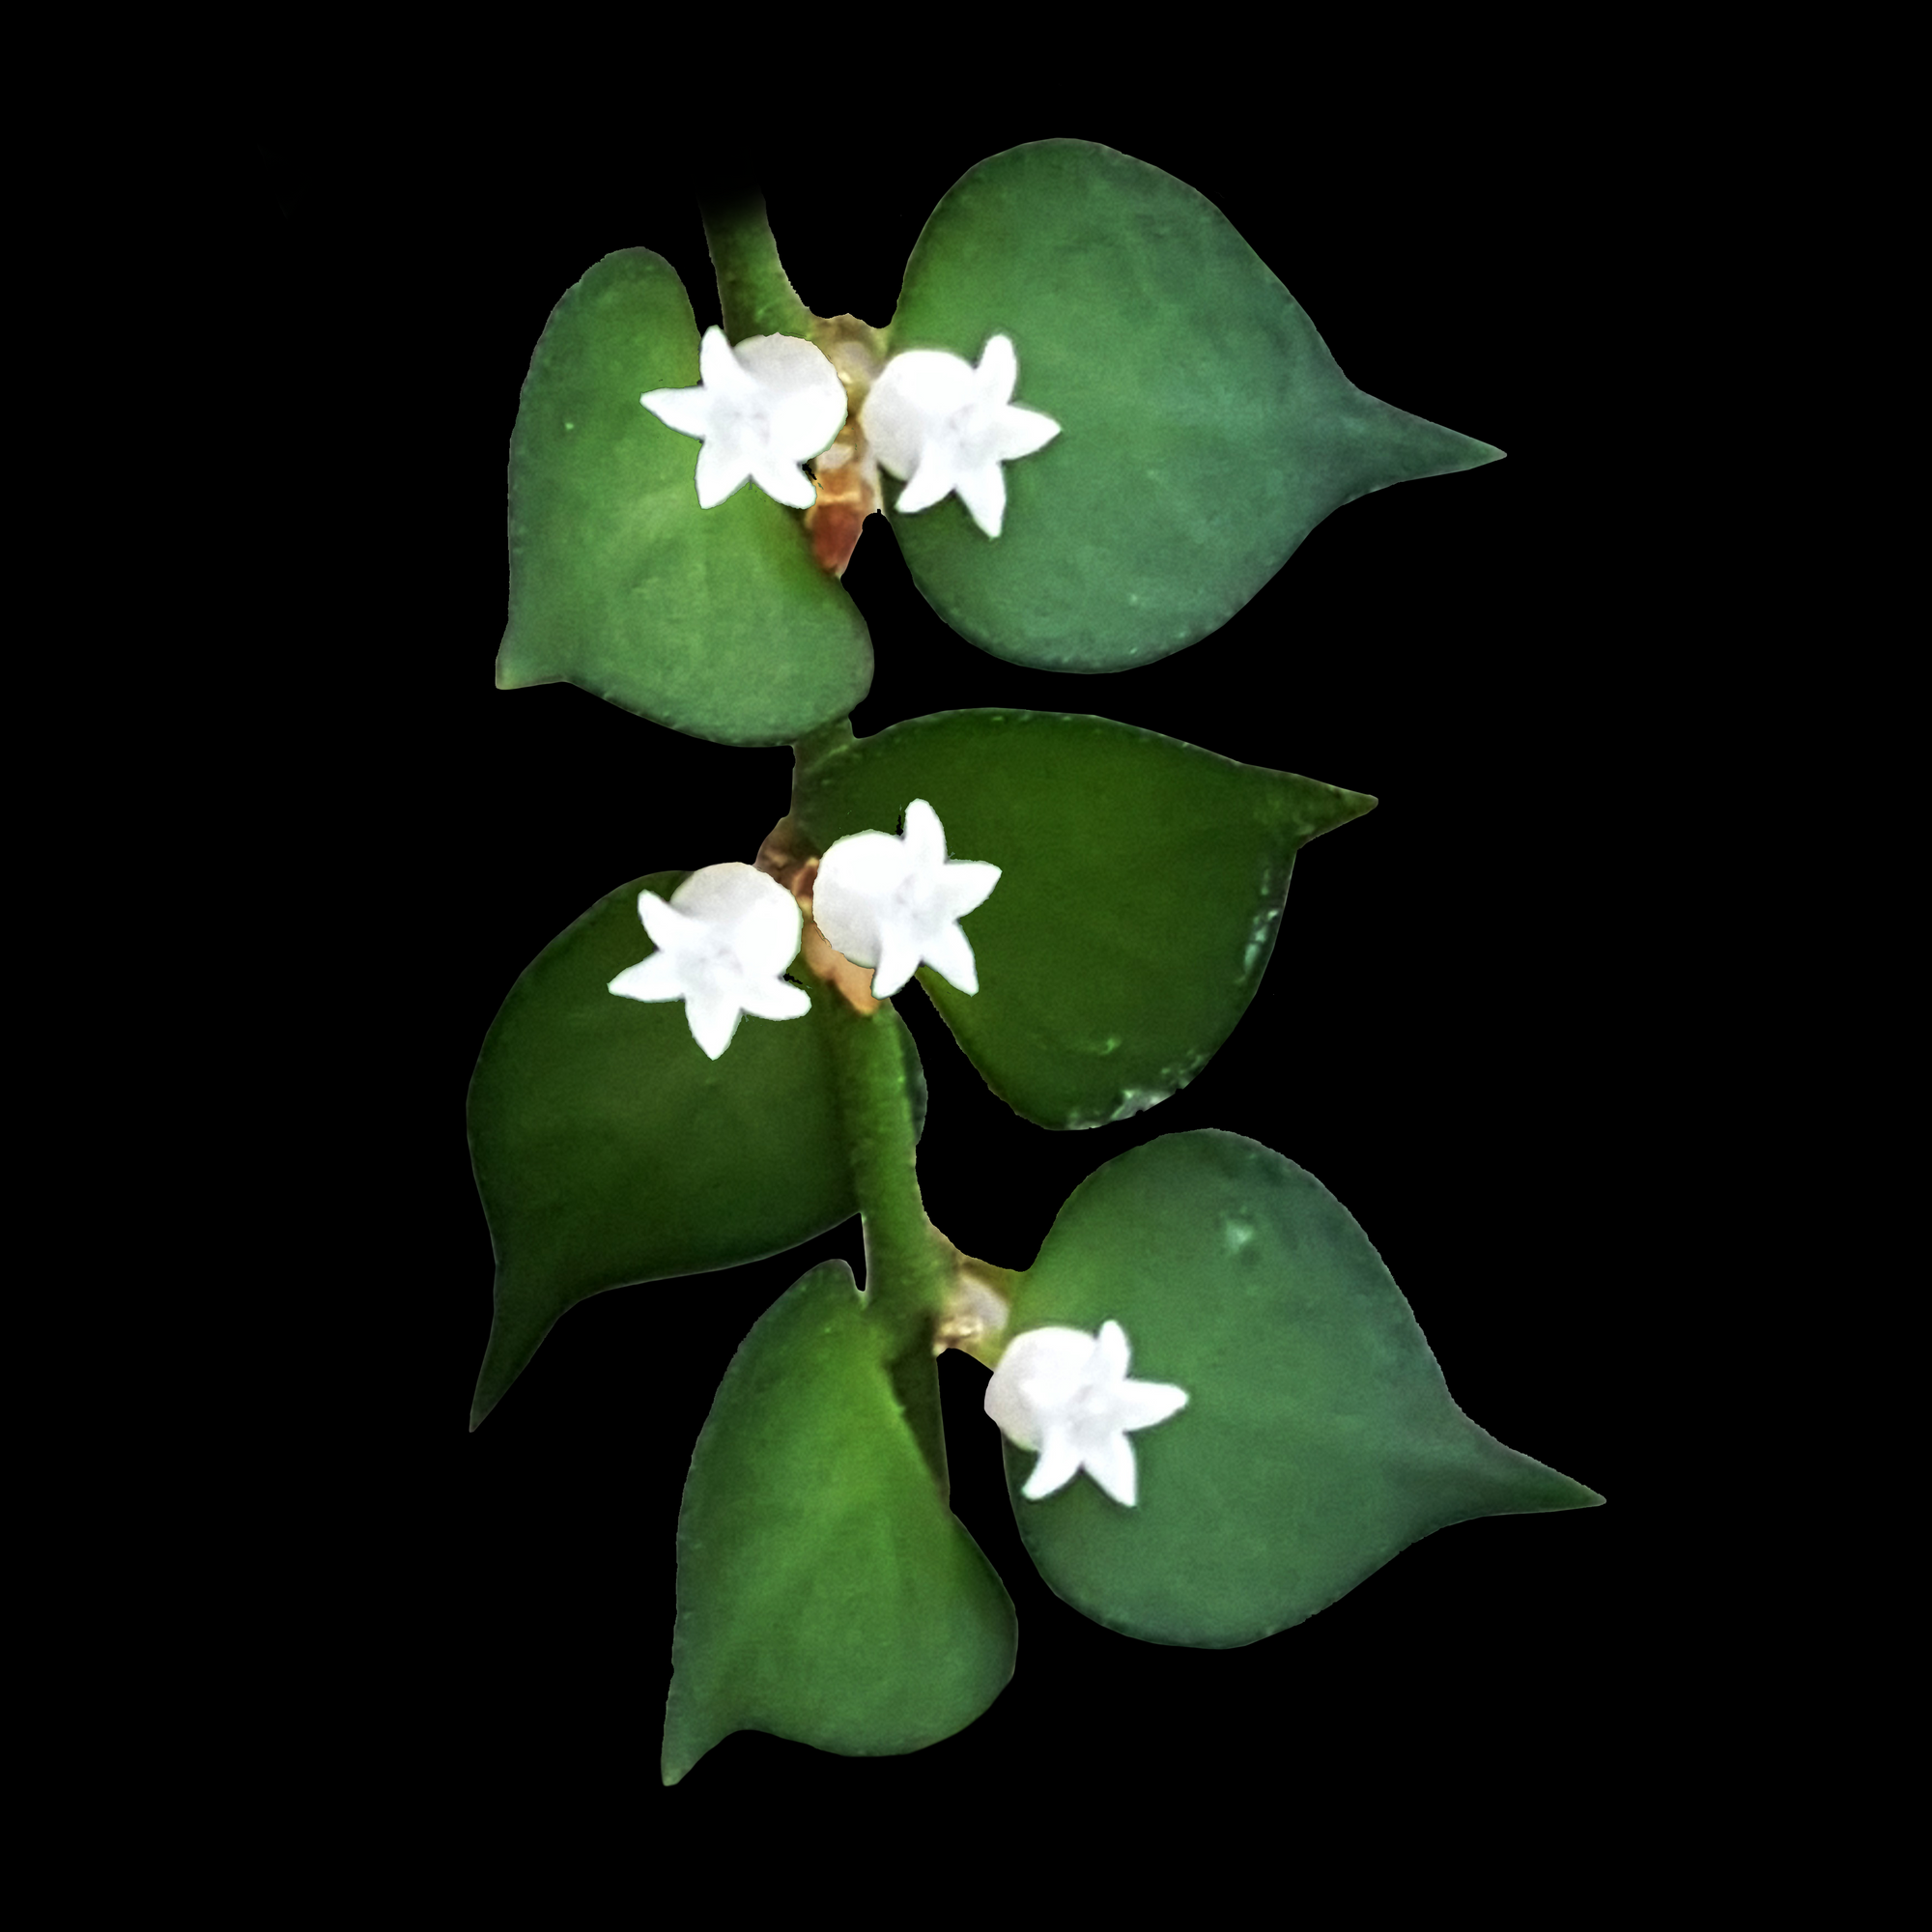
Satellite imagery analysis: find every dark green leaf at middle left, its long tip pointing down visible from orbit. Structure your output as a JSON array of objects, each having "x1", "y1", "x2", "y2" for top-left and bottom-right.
[{"x1": 469, "y1": 871, "x2": 925, "y2": 1428}]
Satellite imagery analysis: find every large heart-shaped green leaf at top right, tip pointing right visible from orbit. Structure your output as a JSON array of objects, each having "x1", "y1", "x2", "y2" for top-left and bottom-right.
[{"x1": 887, "y1": 141, "x2": 1503, "y2": 670}]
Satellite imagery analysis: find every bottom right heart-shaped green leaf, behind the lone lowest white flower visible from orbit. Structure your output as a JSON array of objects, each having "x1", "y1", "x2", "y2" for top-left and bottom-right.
[{"x1": 1003, "y1": 1130, "x2": 1604, "y2": 1650}]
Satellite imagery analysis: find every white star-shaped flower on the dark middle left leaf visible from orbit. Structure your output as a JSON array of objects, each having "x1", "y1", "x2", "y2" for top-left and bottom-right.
[{"x1": 611, "y1": 862, "x2": 811, "y2": 1059}]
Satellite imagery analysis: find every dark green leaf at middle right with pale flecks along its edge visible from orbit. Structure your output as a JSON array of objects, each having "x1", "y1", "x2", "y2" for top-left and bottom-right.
[{"x1": 792, "y1": 711, "x2": 1374, "y2": 1128}]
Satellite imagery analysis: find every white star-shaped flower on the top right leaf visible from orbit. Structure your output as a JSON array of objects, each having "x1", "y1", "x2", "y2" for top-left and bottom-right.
[{"x1": 860, "y1": 336, "x2": 1061, "y2": 537}]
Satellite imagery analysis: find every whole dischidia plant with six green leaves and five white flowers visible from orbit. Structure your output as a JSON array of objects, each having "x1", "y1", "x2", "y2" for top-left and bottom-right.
[{"x1": 469, "y1": 141, "x2": 1602, "y2": 1783}]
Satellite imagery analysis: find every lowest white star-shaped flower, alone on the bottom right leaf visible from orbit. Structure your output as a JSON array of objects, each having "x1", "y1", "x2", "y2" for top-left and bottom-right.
[{"x1": 985, "y1": 1321, "x2": 1188, "y2": 1509}]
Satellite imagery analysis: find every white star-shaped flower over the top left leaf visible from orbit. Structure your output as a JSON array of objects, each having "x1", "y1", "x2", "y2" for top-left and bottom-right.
[{"x1": 638, "y1": 325, "x2": 844, "y2": 510}]
